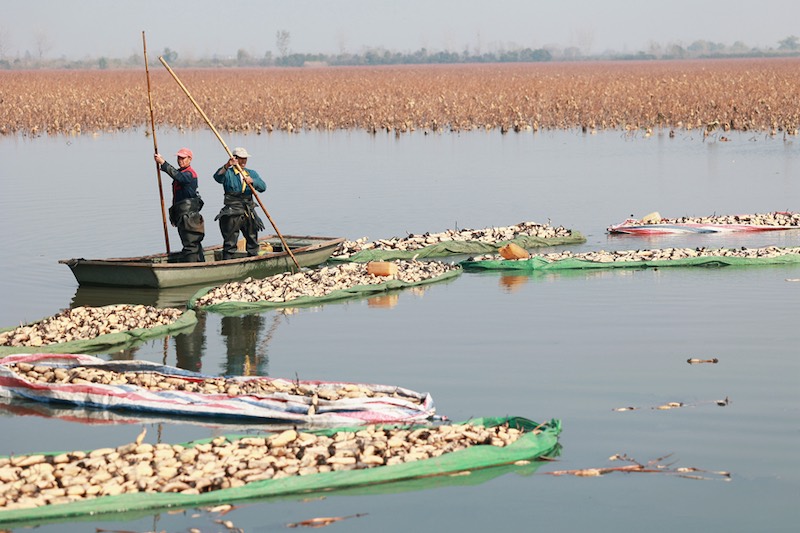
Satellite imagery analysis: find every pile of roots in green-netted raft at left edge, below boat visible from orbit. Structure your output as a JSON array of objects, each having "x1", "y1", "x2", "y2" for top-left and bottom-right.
[{"x1": 0, "y1": 304, "x2": 182, "y2": 346}]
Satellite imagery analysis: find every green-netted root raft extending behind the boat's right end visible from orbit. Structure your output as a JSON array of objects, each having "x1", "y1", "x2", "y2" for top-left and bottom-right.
[{"x1": 331, "y1": 222, "x2": 586, "y2": 262}]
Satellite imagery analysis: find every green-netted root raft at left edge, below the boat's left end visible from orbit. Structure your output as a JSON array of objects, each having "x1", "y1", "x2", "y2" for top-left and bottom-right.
[{"x1": 0, "y1": 304, "x2": 197, "y2": 355}]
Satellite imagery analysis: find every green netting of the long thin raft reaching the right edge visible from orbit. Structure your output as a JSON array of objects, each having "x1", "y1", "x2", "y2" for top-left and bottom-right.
[{"x1": 459, "y1": 254, "x2": 800, "y2": 271}]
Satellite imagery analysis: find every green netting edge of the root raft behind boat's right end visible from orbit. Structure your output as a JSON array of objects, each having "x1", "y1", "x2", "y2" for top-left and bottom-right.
[{"x1": 330, "y1": 231, "x2": 586, "y2": 263}]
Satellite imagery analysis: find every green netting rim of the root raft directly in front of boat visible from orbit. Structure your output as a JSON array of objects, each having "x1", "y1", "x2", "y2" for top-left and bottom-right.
[{"x1": 188, "y1": 268, "x2": 463, "y2": 315}]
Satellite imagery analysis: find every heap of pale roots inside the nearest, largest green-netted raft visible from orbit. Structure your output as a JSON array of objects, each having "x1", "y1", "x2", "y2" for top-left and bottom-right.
[{"x1": 0, "y1": 424, "x2": 537, "y2": 510}]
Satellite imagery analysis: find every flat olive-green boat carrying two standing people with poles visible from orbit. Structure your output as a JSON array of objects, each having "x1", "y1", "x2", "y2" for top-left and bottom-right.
[{"x1": 59, "y1": 235, "x2": 344, "y2": 288}]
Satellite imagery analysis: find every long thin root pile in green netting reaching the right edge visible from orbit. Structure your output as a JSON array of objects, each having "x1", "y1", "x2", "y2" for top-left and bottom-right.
[{"x1": 472, "y1": 246, "x2": 800, "y2": 263}]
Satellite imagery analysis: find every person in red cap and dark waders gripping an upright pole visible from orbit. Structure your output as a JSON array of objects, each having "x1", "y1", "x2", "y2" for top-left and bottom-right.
[{"x1": 154, "y1": 148, "x2": 206, "y2": 263}]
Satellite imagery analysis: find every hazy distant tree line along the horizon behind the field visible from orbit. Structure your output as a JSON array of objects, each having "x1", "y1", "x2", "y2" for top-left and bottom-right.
[{"x1": 0, "y1": 30, "x2": 800, "y2": 70}]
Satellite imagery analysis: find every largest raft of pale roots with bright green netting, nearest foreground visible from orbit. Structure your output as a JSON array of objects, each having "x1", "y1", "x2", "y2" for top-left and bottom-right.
[{"x1": 0, "y1": 417, "x2": 561, "y2": 527}]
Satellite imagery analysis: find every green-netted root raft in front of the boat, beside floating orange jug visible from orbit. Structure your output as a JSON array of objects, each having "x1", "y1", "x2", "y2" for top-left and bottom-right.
[{"x1": 188, "y1": 261, "x2": 462, "y2": 314}]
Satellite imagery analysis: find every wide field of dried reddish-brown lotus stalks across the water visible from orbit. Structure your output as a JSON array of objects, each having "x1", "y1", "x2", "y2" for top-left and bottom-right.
[{"x1": 0, "y1": 58, "x2": 800, "y2": 136}]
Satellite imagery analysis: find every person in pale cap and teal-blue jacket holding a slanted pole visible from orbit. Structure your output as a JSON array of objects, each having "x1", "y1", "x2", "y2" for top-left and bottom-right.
[{"x1": 214, "y1": 147, "x2": 267, "y2": 259}]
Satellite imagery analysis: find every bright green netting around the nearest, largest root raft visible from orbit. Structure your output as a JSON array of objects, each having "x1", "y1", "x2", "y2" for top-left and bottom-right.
[{"x1": 0, "y1": 417, "x2": 561, "y2": 527}]
